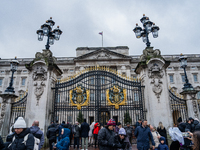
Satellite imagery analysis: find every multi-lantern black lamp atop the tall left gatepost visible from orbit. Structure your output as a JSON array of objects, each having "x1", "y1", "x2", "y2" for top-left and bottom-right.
[{"x1": 36, "y1": 17, "x2": 62, "y2": 49}]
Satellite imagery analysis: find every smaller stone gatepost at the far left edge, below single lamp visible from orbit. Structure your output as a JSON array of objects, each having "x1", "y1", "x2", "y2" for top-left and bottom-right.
[{"x1": 0, "y1": 92, "x2": 18, "y2": 137}]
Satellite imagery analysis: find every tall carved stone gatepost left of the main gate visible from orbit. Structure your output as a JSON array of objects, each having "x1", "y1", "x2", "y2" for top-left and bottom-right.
[{"x1": 25, "y1": 50, "x2": 62, "y2": 132}]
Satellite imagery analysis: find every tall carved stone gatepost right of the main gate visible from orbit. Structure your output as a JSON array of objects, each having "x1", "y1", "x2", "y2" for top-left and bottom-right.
[{"x1": 135, "y1": 47, "x2": 173, "y2": 128}]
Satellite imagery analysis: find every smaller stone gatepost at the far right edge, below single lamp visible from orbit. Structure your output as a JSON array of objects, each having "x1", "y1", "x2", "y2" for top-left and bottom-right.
[{"x1": 180, "y1": 88, "x2": 200, "y2": 119}]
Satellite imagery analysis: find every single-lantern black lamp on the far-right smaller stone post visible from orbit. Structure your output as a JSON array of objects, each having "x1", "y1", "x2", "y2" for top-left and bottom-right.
[{"x1": 179, "y1": 54, "x2": 194, "y2": 91}]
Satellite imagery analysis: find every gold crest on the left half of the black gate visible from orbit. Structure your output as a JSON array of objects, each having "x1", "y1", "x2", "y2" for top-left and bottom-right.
[{"x1": 70, "y1": 84, "x2": 90, "y2": 110}]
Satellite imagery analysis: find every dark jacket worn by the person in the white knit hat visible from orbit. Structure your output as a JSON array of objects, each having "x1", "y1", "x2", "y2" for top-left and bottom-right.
[{"x1": 8, "y1": 128, "x2": 35, "y2": 150}]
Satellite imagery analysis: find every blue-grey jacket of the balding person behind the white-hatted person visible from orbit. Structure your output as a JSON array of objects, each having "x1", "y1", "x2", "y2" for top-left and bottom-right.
[{"x1": 30, "y1": 126, "x2": 44, "y2": 150}]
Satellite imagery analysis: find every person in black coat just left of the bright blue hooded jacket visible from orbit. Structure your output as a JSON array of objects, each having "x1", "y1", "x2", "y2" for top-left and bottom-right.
[{"x1": 47, "y1": 124, "x2": 58, "y2": 150}]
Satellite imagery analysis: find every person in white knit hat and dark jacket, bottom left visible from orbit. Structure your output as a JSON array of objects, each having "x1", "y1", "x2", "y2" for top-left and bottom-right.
[{"x1": 7, "y1": 117, "x2": 35, "y2": 150}]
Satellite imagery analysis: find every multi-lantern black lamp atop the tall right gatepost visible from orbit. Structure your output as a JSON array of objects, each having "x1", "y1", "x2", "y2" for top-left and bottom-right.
[{"x1": 133, "y1": 14, "x2": 159, "y2": 47}]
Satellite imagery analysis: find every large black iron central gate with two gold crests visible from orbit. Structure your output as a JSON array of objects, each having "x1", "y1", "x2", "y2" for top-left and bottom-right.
[{"x1": 52, "y1": 67, "x2": 146, "y2": 124}]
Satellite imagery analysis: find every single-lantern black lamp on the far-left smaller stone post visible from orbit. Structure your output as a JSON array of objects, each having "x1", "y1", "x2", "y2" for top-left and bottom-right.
[{"x1": 5, "y1": 57, "x2": 19, "y2": 93}]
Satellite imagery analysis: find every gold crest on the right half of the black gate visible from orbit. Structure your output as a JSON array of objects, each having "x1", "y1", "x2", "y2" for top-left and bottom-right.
[{"x1": 106, "y1": 84, "x2": 126, "y2": 109}]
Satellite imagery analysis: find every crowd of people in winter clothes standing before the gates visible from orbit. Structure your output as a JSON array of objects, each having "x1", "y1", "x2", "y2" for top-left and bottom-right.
[{"x1": 0, "y1": 117, "x2": 200, "y2": 150}]
